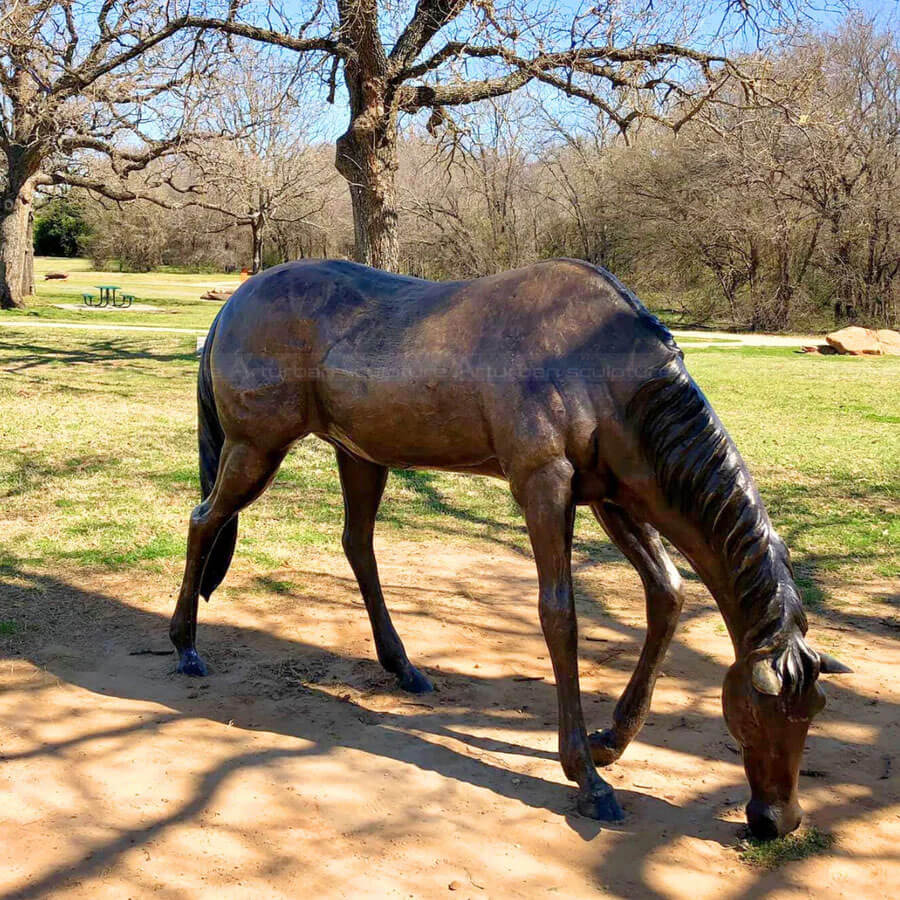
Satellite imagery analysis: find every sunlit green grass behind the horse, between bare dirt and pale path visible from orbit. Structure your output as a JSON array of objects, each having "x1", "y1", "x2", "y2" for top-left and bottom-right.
[{"x1": 0, "y1": 310, "x2": 900, "y2": 605}]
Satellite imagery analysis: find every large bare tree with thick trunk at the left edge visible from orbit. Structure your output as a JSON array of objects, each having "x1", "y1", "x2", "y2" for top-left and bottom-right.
[{"x1": 0, "y1": 0, "x2": 216, "y2": 308}]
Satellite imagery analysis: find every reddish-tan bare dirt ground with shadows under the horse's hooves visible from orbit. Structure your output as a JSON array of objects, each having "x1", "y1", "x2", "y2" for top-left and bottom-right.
[{"x1": 0, "y1": 542, "x2": 900, "y2": 900}]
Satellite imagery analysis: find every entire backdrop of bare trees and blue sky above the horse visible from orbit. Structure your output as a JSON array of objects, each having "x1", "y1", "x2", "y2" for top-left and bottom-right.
[{"x1": 0, "y1": 0, "x2": 900, "y2": 331}]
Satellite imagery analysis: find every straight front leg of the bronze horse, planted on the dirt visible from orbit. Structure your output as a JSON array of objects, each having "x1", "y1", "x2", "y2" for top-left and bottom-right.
[{"x1": 511, "y1": 459, "x2": 624, "y2": 822}]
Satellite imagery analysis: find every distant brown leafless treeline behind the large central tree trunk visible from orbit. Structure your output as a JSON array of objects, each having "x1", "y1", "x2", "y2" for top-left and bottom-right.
[{"x1": 44, "y1": 22, "x2": 900, "y2": 330}]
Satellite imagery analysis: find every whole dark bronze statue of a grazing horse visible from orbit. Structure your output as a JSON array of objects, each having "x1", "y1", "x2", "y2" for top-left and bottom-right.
[{"x1": 171, "y1": 259, "x2": 849, "y2": 837}]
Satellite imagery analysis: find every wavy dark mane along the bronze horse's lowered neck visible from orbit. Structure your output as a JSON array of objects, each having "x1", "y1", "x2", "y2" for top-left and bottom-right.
[{"x1": 627, "y1": 359, "x2": 819, "y2": 696}]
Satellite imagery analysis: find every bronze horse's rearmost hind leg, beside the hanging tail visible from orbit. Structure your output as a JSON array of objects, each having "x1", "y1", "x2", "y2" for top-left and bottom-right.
[{"x1": 169, "y1": 440, "x2": 284, "y2": 675}]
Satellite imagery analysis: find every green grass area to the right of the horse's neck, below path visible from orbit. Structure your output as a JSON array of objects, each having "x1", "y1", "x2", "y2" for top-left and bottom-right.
[{"x1": 687, "y1": 348, "x2": 900, "y2": 602}]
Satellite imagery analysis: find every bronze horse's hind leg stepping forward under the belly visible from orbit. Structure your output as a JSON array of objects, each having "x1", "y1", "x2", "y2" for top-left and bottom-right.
[{"x1": 337, "y1": 448, "x2": 434, "y2": 694}]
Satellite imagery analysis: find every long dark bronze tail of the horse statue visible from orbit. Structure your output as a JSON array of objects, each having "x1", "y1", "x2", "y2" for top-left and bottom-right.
[{"x1": 197, "y1": 316, "x2": 237, "y2": 600}]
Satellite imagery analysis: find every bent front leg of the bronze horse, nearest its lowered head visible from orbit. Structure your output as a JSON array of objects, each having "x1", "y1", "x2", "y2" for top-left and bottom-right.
[{"x1": 589, "y1": 503, "x2": 684, "y2": 766}]
